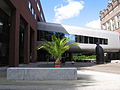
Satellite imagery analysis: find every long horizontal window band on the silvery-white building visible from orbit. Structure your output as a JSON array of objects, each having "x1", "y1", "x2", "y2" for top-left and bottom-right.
[{"x1": 37, "y1": 30, "x2": 108, "y2": 45}]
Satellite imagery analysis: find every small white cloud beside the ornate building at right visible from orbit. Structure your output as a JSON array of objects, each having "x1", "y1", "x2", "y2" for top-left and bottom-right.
[{"x1": 85, "y1": 19, "x2": 101, "y2": 29}]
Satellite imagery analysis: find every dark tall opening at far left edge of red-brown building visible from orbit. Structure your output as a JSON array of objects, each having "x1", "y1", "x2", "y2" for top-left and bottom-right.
[{"x1": 0, "y1": 9, "x2": 10, "y2": 66}]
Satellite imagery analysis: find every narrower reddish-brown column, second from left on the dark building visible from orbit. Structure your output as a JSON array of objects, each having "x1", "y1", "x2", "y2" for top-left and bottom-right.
[{"x1": 24, "y1": 25, "x2": 30, "y2": 64}]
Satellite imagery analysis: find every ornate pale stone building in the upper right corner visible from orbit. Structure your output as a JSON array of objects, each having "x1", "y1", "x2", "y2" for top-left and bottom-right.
[{"x1": 100, "y1": 0, "x2": 120, "y2": 32}]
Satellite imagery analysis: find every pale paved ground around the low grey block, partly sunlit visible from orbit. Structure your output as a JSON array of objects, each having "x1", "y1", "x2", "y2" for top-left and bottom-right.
[{"x1": 0, "y1": 63, "x2": 120, "y2": 90}]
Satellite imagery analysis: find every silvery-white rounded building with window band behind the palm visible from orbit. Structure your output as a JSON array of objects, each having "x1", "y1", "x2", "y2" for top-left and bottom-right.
[{"x1": 37, "y1": 22, "x2": 120, "y2": 61}]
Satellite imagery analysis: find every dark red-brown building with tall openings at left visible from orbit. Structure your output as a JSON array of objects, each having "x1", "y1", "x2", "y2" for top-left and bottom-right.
[{"x1": 0, "y1": 0, "x2": 45, "y2": 66}]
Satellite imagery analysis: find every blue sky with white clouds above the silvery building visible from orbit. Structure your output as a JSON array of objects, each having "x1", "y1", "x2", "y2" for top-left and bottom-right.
[{"x1": 40, "y1": 0, "x2": 108, "y2": 29}]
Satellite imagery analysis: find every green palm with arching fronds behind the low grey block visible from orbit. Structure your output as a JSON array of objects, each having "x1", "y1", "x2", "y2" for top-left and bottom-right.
[{"x1": 37, "y1": 35, "x2": 78, "y2": 64}]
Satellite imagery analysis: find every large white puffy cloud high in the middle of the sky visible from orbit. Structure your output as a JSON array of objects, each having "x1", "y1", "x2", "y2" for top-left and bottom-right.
[{"x1": 54, "y1": 0, "x2": 84, "y2": 23}]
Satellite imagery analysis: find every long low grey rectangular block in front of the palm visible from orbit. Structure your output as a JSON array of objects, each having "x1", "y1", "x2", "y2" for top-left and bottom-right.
[{"x1": 7, "y1": 68, "x2": 77, "y2": 80}]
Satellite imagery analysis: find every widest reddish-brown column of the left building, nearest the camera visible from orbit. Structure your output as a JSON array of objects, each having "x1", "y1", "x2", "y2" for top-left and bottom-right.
[{"x1": 9, "y1": 10, "x2": 20, "y2": 66}]
